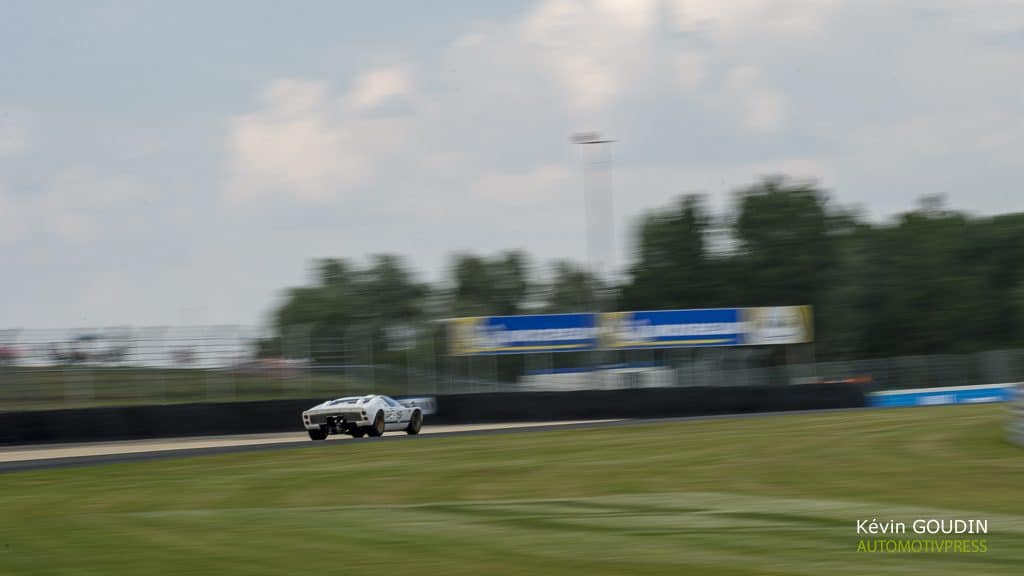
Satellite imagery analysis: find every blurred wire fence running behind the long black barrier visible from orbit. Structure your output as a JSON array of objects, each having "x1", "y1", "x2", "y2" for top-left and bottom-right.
[{"x1": 0, "y1": 325, "x2": 1024, "y2": 411}]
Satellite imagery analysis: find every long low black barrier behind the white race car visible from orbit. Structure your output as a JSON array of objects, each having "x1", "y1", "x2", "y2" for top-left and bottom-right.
[{"x1": 0, "y1": 384, "x2": 865, "y2": 444}]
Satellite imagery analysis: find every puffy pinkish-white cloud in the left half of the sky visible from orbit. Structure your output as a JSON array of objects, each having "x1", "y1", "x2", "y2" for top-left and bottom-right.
[{"x1": 222, "y1": 66, "x2": 421, "y2": 206}]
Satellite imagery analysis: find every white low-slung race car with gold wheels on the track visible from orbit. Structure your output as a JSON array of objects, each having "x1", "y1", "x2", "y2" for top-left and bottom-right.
[{"x1": 302, "y1": 395, "x2": 423, "y2": 440}]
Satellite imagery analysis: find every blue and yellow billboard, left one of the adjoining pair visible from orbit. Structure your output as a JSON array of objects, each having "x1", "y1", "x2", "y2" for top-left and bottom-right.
[{"x1": 449, "y1": 313, "x2": 598, "y2": 356}]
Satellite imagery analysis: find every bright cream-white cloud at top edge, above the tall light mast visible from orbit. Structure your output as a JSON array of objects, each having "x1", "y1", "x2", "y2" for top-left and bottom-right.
[{"x1": 505, "y1": 0, "x2": 840, "y2": 119}]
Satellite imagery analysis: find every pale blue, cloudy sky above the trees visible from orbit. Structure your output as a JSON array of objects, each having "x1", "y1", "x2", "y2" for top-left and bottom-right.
[{"x1": 0, "y1": 0, "x2": 1024, "y2": 328}]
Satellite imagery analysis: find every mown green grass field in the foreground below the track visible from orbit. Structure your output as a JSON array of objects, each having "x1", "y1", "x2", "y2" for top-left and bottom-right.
[{"x1": 0, "y1": 406, "x2": 1024, "y2": 576}]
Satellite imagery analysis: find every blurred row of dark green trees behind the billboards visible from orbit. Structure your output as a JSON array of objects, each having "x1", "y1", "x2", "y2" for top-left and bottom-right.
[{"x1": 261, "y1": 177, "x2": 1024, "y2": 360}]
